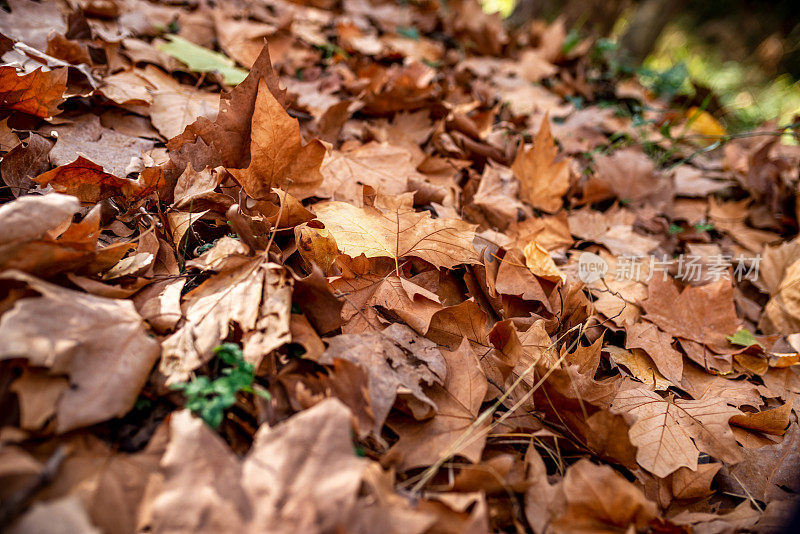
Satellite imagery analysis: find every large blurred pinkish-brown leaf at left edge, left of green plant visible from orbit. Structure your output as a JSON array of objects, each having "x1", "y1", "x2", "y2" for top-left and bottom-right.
[{"x1": 0, "y1": 271, "x2": 159, "y2": 432}]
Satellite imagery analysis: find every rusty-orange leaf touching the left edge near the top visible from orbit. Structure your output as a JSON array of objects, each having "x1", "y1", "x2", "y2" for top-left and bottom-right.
[{"x1": 0, "y1": 67, "x2": 67, "y2": 117}]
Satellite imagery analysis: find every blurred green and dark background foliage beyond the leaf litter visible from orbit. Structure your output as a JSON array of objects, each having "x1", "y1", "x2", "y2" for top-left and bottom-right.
[{"x1": 483, "y1": 0, "x2": 800, "y2": 132}]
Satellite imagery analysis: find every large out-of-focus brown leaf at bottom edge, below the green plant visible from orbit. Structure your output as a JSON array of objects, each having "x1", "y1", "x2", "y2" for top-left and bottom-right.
[{"x1": 149, "y1": 399, "x2": 369, "y2": 533}]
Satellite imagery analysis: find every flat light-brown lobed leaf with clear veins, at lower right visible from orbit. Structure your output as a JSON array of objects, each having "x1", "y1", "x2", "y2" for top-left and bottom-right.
[{"x1": 611, "y1": 388, "x2": 742, "y2": 478}]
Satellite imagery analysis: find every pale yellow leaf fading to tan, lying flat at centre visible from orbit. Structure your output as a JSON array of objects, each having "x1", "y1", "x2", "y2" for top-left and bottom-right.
[{"x1": 314, "y1": 193, "x2": 477, "y2": 273}]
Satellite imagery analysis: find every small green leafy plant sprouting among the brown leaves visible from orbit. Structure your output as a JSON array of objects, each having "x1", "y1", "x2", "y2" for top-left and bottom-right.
[{"x1": 172, "y1": 343, "x2": 271, "y2": 428}]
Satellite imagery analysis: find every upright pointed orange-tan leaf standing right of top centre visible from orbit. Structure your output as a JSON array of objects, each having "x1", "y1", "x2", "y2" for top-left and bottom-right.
[{"x1": 511, "y1": 115, "x2": 569, "y2": 213}]
